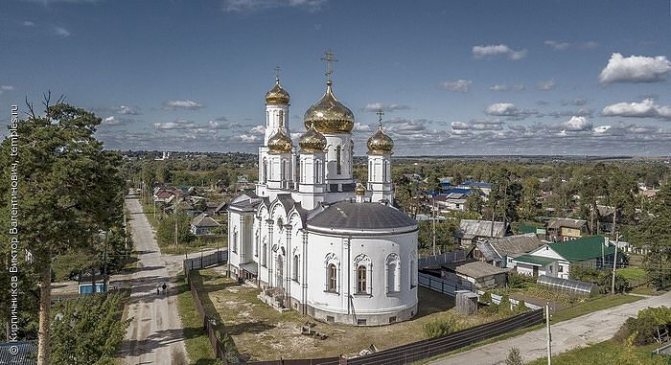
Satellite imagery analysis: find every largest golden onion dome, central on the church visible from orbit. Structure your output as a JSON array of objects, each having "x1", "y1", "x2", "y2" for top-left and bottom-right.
[{"x1": 304, "y1": 81, "x2": 354, "y2": 134}]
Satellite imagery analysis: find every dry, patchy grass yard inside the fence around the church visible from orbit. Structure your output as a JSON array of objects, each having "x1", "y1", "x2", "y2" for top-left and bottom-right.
[{"x1": 192, "y1": 270, "x2": 510, "y2": 360}]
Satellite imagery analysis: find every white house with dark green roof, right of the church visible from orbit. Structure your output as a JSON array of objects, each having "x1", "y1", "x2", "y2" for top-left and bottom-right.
[{"x1": 512, "y1": 236, "x2": 624, "y2": 279}]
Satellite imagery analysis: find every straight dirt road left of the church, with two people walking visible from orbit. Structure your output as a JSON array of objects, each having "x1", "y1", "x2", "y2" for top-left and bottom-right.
[{"x1": 121, "y1": 196, "x2": 188, "y2": 365}]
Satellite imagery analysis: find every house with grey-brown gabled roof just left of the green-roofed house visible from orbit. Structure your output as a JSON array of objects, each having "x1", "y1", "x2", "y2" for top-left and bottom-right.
[{"x1": 468, "y1": 233, "x2": 543, "y2": 268}]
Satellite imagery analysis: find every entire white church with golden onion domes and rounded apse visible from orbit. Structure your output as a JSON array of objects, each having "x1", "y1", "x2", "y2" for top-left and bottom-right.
[{"x1": 228, "y1": 53, "x2": 418, "y2": 326}]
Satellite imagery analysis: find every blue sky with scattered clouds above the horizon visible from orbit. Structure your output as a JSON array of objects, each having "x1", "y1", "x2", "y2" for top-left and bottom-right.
[{"x1": 0, "y1": 0, "x2": 671, "y2": 156}]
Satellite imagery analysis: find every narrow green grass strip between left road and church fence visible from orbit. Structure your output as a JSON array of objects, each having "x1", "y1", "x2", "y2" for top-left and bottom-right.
[{"x1": 177, "y1": 275, "x2": 217, "y2": 365}]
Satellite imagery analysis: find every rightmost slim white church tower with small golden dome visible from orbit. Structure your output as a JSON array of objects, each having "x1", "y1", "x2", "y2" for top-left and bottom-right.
[{"x1": 368, "y1": 111, "x2": 394, "y2": 204}]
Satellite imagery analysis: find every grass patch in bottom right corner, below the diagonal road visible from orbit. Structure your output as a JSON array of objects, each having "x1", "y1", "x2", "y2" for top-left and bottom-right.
[{"x1": 527, "y1": 340, "x2": 669, "y2": 365}]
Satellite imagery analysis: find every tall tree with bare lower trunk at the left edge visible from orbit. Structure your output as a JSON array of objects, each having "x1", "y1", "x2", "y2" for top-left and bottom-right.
[{"x1": 0, "y1": 98, "x2": 124, "y2": 365}]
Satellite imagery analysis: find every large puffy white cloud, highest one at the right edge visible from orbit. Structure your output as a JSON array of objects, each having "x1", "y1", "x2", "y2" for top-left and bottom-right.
[{"x1": 599, "y1": 53, "x2": 671, "y2": 84}]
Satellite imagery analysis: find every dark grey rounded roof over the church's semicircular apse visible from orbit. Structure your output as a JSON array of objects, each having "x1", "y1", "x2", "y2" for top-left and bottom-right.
[{"x1": 308, "y1": 201, "x2": 417, "y2": 230}]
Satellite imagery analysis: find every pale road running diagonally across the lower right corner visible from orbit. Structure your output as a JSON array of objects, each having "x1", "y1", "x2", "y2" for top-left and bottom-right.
[{"x1": 429, "y1": 292, "x2": 671, "y2": 365}]
